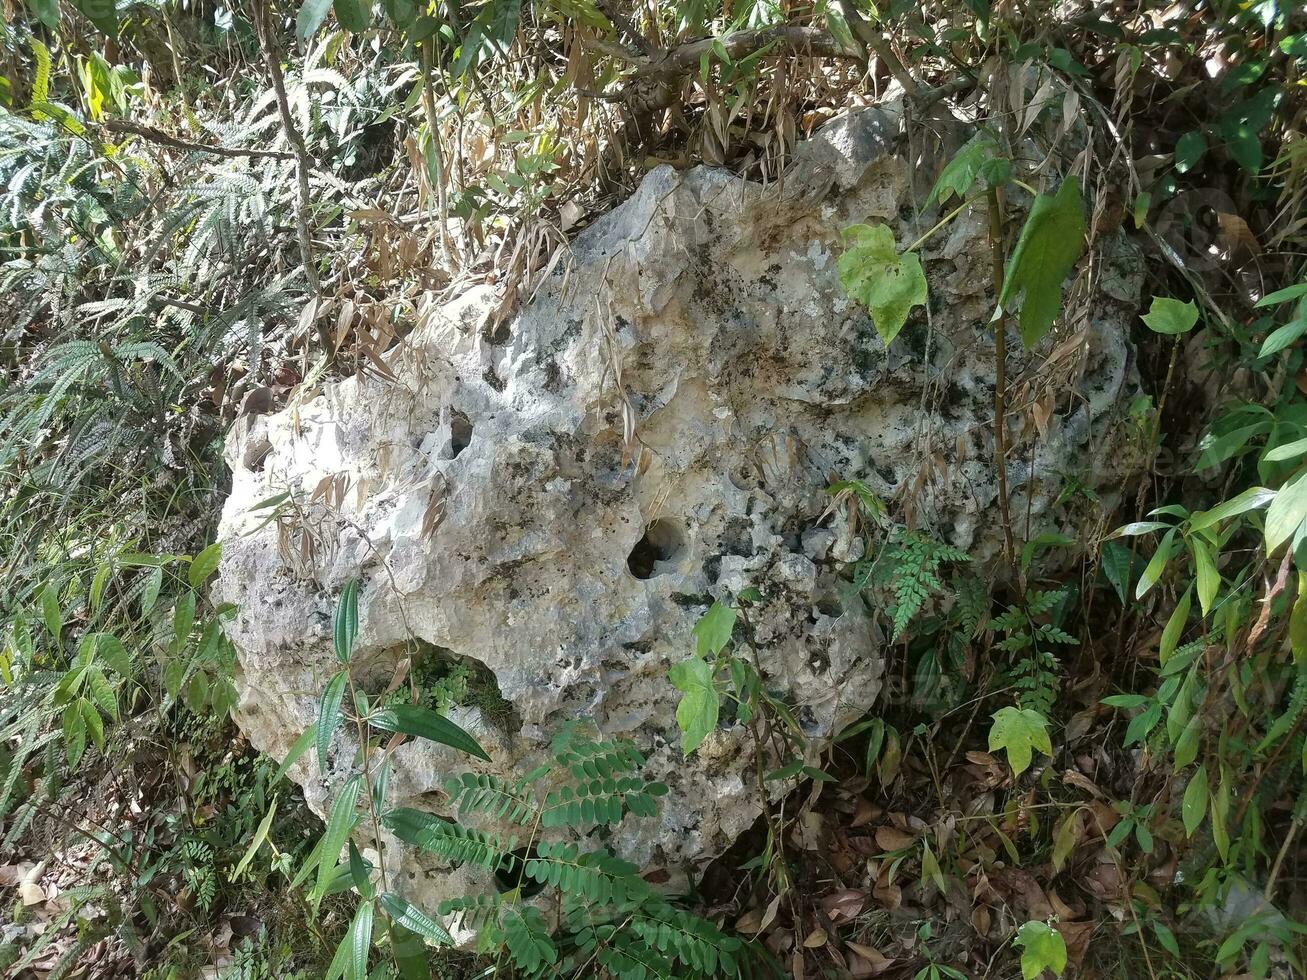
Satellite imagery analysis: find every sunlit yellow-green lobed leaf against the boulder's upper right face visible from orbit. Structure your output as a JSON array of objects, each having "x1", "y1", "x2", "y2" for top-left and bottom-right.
[{"x1": 839, "y1": 225, "x2": 927, "y2": 346}]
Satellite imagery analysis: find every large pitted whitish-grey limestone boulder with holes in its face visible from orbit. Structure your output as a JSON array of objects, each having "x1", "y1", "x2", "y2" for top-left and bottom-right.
[{"x1": 217, "y1": 110, "x2": 1138, "y2": 902}]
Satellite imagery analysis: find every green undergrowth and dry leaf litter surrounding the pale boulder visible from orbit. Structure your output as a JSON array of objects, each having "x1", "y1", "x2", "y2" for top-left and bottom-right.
[{"x1": 0, "y1": 0, "x2": 1307, "y2": 980}]
